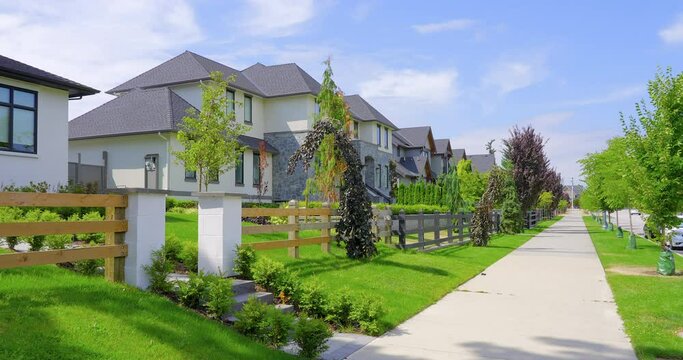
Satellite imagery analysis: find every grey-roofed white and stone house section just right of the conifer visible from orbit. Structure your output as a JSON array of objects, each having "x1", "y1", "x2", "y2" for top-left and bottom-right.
[{"x1": 344, "y1": 95, "x2": 397, "y2": 202}]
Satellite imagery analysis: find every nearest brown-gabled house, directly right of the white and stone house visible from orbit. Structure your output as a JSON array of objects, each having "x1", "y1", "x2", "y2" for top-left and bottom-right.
[{"x1": 393, "y1": 126, "x2": 437, "y2": 184}]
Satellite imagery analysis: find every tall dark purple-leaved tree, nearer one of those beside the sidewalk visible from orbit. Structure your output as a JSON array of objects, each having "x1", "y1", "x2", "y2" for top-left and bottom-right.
[{"x1": 503, "y1": 126, "x2": 549, "y2": 213}]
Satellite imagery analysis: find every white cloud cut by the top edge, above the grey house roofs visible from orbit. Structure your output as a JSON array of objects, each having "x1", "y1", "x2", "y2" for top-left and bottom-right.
[{"x1": 242, "y1": 0, "x2": 315, "y2": 37}]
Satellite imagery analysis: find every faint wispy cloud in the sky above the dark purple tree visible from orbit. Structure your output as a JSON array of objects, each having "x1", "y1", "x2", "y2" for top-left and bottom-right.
[{"x1": 482, "y1": 59, "x2": 547, "y2": 95}]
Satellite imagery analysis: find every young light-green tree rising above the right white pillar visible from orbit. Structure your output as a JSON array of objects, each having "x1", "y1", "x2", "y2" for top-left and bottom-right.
[{"x1": 173, "y1": 71, "x2": 248, "y2": 191}]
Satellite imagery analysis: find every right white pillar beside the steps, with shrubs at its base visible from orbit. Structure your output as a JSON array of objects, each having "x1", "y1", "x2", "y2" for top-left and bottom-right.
[{"x1": 192, "y1": 192, "x2": 242, "y2": 275}]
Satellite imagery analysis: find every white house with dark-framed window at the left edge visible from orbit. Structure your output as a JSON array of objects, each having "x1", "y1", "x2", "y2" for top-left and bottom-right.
[{"x1": 0, "y1": 55, "x2": 99, "y2": 186}]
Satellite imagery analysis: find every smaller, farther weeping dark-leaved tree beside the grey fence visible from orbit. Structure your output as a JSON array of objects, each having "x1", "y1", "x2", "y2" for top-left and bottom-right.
[{"x1": 470, "y1": 167, "x2": 505, "y2": 246}]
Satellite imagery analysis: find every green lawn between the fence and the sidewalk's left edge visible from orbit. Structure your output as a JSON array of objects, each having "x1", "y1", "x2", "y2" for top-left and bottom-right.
[{"x1": 167, "y1": 214, "x2": 556, "y2": 331}]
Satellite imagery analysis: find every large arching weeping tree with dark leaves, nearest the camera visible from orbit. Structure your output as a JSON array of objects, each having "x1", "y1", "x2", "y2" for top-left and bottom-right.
[{"x1": 287, "y1": 119, "x2": 377, "y2": 259}]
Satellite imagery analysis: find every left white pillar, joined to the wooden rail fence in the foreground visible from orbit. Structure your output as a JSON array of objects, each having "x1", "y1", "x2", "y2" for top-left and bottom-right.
[{"x1": 123, "y1": 189, "x2": 166, "y2": 289}]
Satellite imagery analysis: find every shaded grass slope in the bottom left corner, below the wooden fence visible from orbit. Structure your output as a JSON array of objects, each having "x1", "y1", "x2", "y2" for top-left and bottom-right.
[{"x1": 0, "y1": 250, "x2": 293, "y2": 359}]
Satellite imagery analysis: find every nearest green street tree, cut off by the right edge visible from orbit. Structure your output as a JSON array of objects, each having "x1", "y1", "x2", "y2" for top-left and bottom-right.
[{"x1": 623, "y1": 69, "x2": 683, "y2": 272}]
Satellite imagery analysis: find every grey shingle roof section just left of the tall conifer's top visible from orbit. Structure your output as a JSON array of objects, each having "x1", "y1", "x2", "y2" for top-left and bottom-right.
[{"x1": 242, "y1": 63, "x2": 320, "y2": 97}]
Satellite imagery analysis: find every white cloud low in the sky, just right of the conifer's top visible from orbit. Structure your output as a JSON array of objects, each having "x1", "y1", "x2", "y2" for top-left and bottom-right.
[{"x1": 359, "y1": 69, "x2": 458, "y2": 103}]
